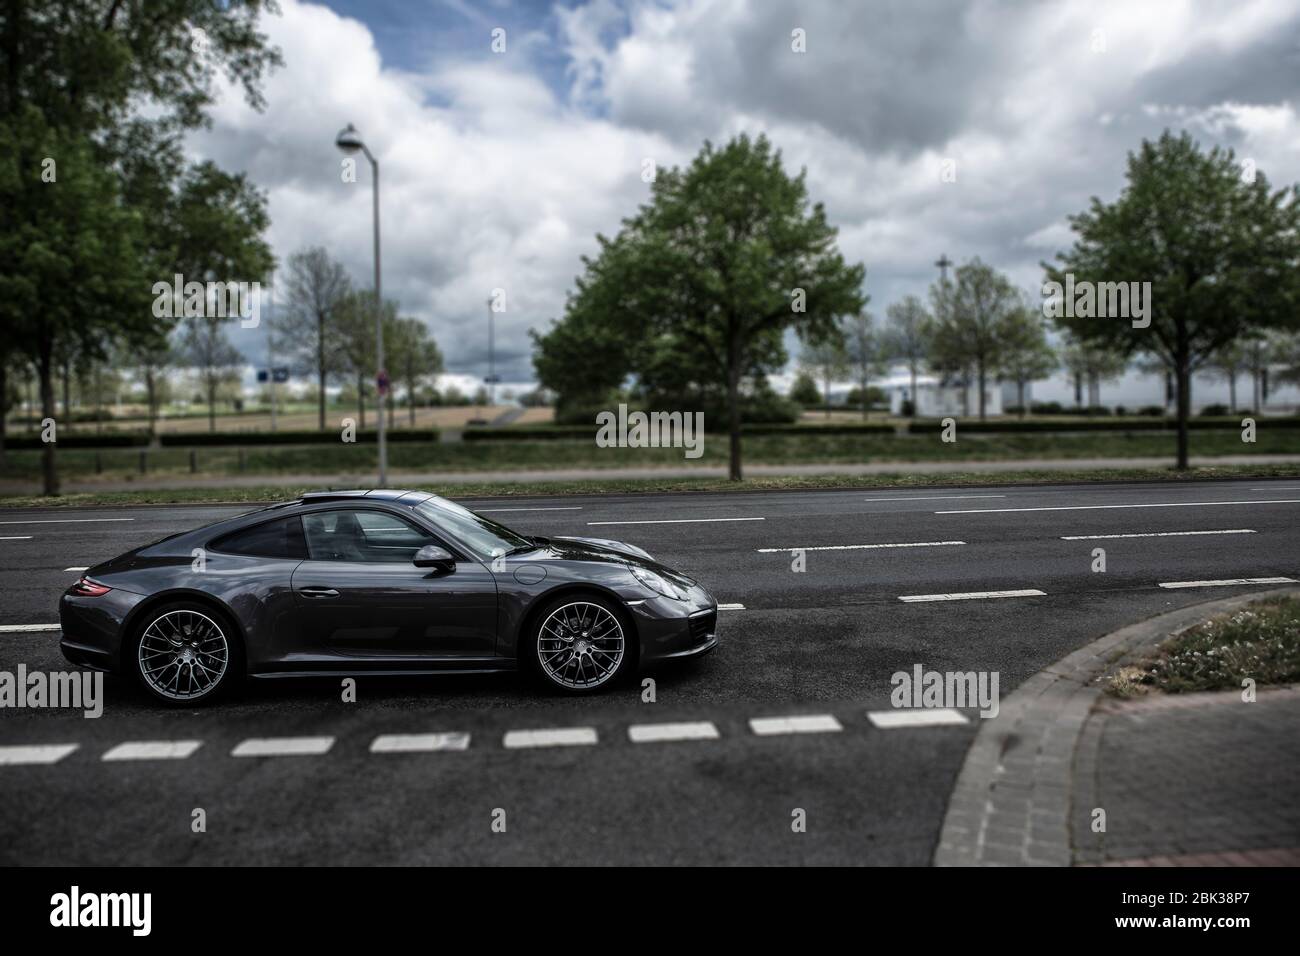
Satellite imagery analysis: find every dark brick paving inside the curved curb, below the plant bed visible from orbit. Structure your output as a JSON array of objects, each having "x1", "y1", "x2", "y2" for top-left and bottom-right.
[{"x1": 1070, "y1": 688, "x2": 1300, "y2": 866}]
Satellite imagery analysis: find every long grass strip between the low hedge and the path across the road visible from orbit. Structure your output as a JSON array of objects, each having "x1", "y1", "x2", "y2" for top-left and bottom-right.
[{"x1": 0, "y1": 427, "x2": 1300, "y2": 481}]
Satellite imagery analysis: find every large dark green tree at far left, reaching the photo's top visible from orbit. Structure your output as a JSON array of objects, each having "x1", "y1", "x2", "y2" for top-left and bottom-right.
[{"x1": 0, "y1": 0, "x2": 278, "y2": 494}]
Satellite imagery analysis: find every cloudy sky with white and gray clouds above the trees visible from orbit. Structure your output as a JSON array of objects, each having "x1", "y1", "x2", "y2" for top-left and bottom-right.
[{"x1": 191, "y1": 0, "x2": 1300, "y2": 402}]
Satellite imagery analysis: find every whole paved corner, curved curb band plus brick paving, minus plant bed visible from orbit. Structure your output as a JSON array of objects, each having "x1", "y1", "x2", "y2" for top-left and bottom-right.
[{"x1": 935, "y1": 588, "x2": 1300, "y2": 866}]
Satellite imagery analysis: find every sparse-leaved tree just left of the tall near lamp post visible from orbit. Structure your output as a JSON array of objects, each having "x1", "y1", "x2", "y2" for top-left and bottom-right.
[{"x1": 282, "y1": 246, "x2": 350, "y2": 432}]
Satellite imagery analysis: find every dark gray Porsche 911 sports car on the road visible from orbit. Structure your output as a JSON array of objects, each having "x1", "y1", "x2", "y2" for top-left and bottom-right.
[{"x1": 59, "y1": 489, "x2": 718, "y2": 705}]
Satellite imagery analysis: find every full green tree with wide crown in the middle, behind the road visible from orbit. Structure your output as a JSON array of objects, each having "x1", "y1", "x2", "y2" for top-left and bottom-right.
[{"x1": 537, "y1": 135, "x2": 866, "y2": 480}]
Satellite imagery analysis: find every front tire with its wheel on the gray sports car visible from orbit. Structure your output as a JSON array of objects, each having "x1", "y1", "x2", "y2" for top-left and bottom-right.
[{"x1": 520, "y1": 592, "x2": 637, "y2": 695}]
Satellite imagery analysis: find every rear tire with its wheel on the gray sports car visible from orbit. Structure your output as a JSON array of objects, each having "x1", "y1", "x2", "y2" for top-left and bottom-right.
[{"x1": 124, "y1": 601, "x2": 244, "y2": 708}]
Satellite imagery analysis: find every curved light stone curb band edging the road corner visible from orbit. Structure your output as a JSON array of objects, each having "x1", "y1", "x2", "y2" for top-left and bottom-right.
[{"x1": 933, "y1": 588, "x2": 1300, "y2": 866}]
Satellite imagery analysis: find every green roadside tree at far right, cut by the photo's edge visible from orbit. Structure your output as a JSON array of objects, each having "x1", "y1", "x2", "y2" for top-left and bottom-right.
[{"x1": 1044, "y1": 131, "x2": 1300, "y2": 468}]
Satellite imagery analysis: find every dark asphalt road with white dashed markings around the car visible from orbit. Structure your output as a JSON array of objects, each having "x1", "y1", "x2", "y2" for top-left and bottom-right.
[{"x1": 0, "y1": 479, "x2": 1300, "y2": 865}]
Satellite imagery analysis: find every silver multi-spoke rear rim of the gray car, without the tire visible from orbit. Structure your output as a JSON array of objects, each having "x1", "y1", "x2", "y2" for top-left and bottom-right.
[{"x1": 135, "y1": 610, "x2": 230, "y2": 700}]
